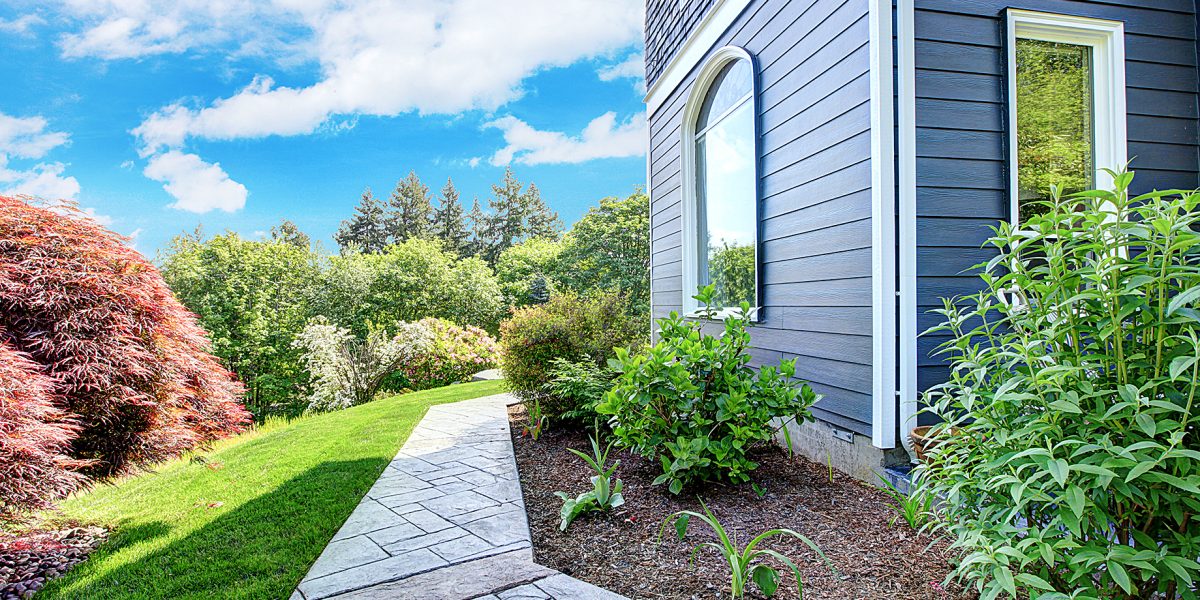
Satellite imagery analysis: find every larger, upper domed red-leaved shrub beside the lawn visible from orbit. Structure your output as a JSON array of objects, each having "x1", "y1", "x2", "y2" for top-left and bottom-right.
[{"x1": 0, "y1": 197, "x2": 248, "y2": 476}]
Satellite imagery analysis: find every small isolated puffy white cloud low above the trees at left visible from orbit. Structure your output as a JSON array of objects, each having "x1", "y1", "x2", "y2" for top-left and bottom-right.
[{"x1": 142, "y1": 150, "x2": 246, "y2": 214}]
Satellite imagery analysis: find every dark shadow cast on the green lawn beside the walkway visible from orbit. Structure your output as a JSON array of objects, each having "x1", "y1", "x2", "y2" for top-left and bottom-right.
[{"x1": 40, "y1": 458, "x2": 389, "y2": 599}]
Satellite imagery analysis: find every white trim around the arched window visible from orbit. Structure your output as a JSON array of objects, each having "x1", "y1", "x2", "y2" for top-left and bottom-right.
[{"x1": 679, "y1": 46, "x2": 762, "y2": 320}]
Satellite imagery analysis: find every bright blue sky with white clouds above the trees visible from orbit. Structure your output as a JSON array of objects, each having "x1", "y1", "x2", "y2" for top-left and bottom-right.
[{"x1": 0, "y1": 0, "x2": 646, "y2": 256}]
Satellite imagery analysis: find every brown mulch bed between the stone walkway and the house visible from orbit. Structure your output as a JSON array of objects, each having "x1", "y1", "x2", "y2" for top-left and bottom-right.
[{"x1": 510, "y1": 407, "x2": 971, "y2": 600}]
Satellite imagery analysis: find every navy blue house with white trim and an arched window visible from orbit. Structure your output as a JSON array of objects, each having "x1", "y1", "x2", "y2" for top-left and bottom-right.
[{"x1": 646, "y1": 0, "x2": 1200, "y2": 479}]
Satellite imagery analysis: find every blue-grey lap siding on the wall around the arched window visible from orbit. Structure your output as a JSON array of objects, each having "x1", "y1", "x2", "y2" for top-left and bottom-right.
[{"x1": 647, "y1": 0, "x2": 871, "y2": 434}]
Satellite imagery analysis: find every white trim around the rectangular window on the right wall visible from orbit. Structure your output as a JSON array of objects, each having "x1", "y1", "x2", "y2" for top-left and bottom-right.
[{"x1": 1008, "y1": 10, "x2": 1128, "y2": 226}]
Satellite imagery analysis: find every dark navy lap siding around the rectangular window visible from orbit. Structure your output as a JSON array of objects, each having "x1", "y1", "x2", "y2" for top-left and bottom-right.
[{"x1": 914, "y1": 0, "x2": 1200, "y2": 408}]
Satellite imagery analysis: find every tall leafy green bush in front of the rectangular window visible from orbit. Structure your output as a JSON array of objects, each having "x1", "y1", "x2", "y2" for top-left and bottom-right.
[{"x1": 918, "y1": 173, "x2": 1200, "y2": 599}]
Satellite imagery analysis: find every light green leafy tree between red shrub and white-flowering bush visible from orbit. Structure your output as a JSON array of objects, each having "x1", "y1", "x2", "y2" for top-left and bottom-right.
[{"x1": 162, "y1": 226, "x2": 319, "y2": 420}]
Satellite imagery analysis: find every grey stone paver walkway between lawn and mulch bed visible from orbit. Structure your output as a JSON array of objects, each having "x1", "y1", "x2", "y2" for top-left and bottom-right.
[{"x1": 292, "y1": 394, "x2": 623, "y2": 600}]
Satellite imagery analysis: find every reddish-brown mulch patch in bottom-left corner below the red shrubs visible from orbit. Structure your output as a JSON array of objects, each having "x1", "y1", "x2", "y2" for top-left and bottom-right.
[{"x1": 0, "y1": 527, "x2": 108, "y2": 600}]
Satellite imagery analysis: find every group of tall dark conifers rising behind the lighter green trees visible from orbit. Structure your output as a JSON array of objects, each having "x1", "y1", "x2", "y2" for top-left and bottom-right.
[{"x1": 334, "y1": 169, "x2": 563, "y2": 265}]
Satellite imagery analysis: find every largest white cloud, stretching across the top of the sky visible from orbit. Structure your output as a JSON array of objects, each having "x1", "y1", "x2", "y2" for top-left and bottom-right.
[{"x1": 115, "y1": 0, "x2": 642, "y2": 156}]
